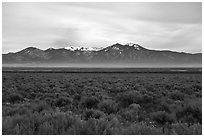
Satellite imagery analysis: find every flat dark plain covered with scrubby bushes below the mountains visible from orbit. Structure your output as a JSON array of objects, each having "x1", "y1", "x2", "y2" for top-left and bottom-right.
[{"x1": 2, "y1": 68, "x2": 202, "y2": 135}]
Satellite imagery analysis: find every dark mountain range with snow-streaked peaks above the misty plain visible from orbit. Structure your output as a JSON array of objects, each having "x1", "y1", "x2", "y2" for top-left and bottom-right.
[{"x1": 2, "y1": 43, "x2": 202, "y2": 67}]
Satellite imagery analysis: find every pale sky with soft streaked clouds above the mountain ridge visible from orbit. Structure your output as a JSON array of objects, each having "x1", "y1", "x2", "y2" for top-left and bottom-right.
[{"x1": 2, "y1": 2, "x2": 202, "y2": 53}]
